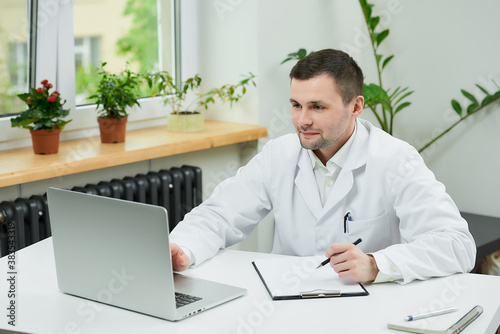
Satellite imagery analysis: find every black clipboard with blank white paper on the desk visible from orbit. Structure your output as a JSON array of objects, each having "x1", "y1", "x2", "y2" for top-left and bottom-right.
[{"x1": 252, "y1": 256, "x2": 369, "y2": 300}]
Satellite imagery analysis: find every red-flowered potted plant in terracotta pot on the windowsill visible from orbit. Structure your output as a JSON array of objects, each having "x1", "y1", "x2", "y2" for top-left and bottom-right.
[{"x1": 10, "y1": 80, "x2": 71, "y2": 154}]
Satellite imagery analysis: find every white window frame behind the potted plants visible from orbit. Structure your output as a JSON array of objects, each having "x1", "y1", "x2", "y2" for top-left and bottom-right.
[{"x1": 0, "y1": 0, "x2": 198, "y2": 150}]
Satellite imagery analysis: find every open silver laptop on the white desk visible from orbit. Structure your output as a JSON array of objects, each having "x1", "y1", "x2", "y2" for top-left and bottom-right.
[{"x1": 47, "y1": 188, "x2": 246, "y2": 321}]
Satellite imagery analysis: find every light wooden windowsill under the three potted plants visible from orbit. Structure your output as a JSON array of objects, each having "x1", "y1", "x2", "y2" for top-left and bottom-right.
[{"x1": 0, "y1": 121, "x2": 267, "y2": 187}]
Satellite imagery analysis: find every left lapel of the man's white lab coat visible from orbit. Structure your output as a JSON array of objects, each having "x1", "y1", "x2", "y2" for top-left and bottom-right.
[{"x1": 295, "y1": 149, "x2": 323, "y2": 219}]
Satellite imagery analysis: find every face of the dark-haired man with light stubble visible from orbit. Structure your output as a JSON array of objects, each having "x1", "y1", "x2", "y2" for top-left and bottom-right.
[{"x1": 290, "y1": 74, "x2": 362, "y2": 160}]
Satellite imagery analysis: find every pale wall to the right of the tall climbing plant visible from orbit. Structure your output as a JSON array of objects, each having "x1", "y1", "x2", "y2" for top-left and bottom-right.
[{"x1": 380, "y1": 0, "x2": 500, "y2": 217}]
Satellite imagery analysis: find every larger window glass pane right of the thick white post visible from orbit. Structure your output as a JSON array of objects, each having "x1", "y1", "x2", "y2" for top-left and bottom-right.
[{"x1": 73, "y1": 0, "x2": 172, "y2": 105}]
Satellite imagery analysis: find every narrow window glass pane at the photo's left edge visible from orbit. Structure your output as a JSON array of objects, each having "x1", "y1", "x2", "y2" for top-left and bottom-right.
[{"x1": 0, "y1": 0, "x2": 28, "y2": 115}]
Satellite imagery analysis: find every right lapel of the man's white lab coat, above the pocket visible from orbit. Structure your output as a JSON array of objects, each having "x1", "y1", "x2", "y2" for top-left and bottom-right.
[{"x1": 319, "y1": 122, "x2": 369, "y2": 218}]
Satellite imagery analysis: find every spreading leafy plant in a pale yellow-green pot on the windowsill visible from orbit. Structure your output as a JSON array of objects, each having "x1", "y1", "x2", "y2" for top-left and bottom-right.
[{"x1": 146, "y1": 71, "x2": 256, "y2": 132}]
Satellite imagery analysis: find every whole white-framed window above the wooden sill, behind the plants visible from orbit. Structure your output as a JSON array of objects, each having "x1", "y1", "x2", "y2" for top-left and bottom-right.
[{"x1": 0, "y1": 0, "x2": 180, "y2": 150}]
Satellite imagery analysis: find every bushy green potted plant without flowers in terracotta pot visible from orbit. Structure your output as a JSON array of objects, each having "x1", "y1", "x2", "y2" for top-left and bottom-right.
[{"x1": 89, "y1": 62, "x2": 140, "y2": 143}]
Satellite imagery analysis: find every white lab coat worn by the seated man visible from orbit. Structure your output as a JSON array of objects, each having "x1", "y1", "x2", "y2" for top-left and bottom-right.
[{"x1": 171, "y1": 119, "x2": 476, "y2": 283}]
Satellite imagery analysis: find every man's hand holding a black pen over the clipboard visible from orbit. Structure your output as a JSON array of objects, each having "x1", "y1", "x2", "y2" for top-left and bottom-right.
[{"x1": 326, "y1": 244, "x2": 379, "y2": 283}]
